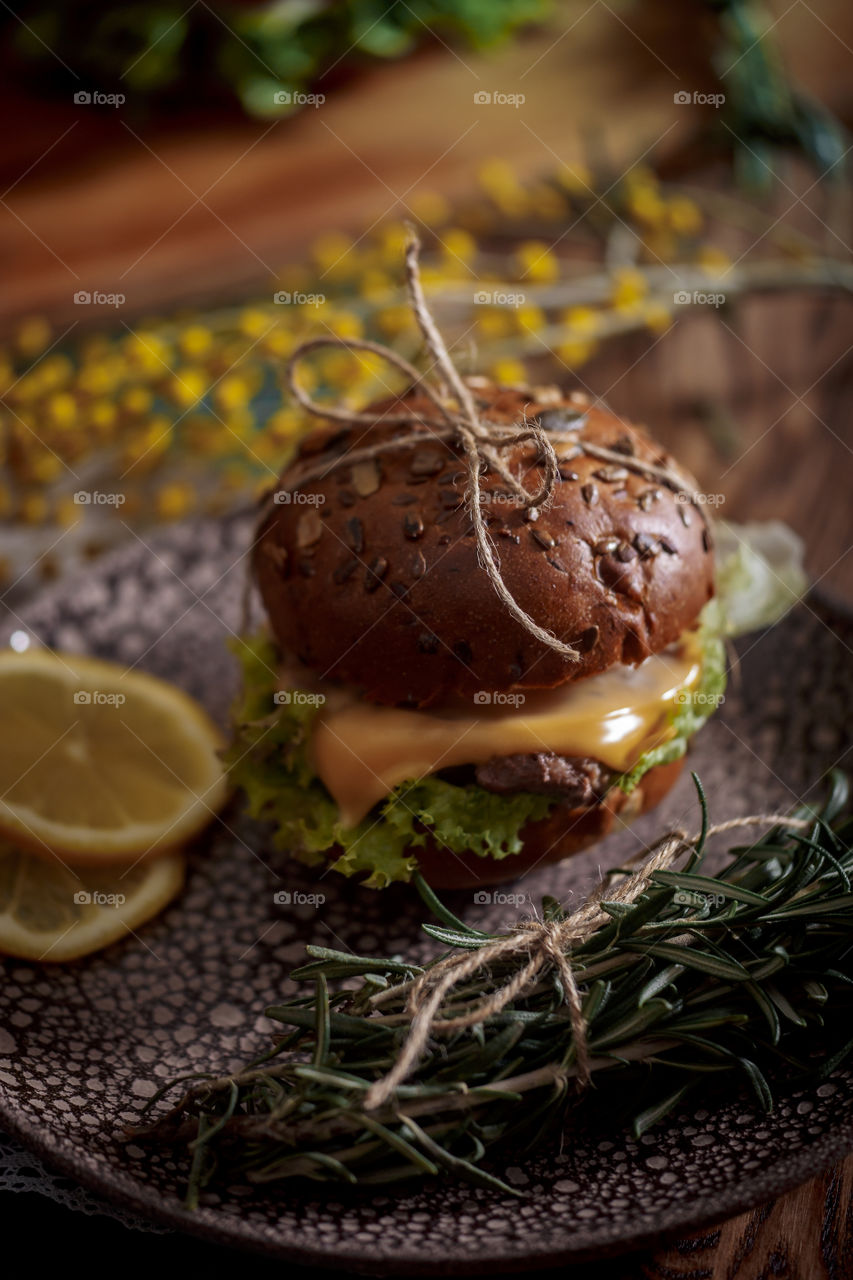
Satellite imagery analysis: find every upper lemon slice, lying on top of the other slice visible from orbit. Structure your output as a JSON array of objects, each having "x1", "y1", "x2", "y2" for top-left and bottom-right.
[{"x1": 0, "y1": 649, "x2": 227, "y2": 865}]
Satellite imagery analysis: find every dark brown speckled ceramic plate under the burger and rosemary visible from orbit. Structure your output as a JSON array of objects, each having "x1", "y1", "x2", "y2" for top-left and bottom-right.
[{"x1": 0, "y1": 520, "x2": 853, "y2": 1275}]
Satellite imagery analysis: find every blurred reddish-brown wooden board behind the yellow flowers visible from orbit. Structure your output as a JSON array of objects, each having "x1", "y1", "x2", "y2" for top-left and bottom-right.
[{"x1": 0, "y1": 0, "x2": 853, "y2": 332}]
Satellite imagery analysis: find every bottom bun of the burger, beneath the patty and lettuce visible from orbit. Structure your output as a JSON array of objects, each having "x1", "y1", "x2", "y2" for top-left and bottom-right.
[{"x1": 411, "y1": 758, "x2": 684, "y2": 888}]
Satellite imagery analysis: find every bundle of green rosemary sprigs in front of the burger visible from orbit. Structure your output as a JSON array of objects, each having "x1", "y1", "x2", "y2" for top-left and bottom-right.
[{"x1": 133, "y1": 772, "x2": 853, "y2": 1206}]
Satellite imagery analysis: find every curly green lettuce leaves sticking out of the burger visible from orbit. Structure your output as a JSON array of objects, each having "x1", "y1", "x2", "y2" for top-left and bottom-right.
[{"x1": 225, "y1": 526, "x2": 804, "y2": 888}]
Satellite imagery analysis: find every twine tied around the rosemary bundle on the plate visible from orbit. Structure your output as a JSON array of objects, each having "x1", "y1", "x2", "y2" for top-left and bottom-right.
[{"x1": 364, "y1": 814, "x2": 811, "y2": 1111}]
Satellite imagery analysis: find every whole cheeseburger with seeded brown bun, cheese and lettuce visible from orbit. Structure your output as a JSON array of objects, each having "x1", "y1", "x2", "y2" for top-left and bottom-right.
[{"x1": 229, "y1": 378, "x2": 725, "y2": 887}]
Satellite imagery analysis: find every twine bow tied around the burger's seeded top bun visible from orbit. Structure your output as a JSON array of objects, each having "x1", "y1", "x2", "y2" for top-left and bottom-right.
[{"x1": 252, "y1": 227, "x2": 708, "y2": 662}]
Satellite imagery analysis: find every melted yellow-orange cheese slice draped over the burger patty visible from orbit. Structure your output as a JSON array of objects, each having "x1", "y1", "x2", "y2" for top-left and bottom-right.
[{"x1": 309, "y1": 632, "x2": 701, "y2": 827}]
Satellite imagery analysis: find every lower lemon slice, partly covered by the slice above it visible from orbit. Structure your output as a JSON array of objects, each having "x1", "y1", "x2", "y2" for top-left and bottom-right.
[{"x1": 0, "y1": 842, "x2": 184, "y2": 963}]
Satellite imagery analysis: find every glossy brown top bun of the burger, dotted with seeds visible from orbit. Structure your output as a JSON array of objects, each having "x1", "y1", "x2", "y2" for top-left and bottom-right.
[{"x1": 254, "y1": 379, "x2": 713, "y2": 707}]
